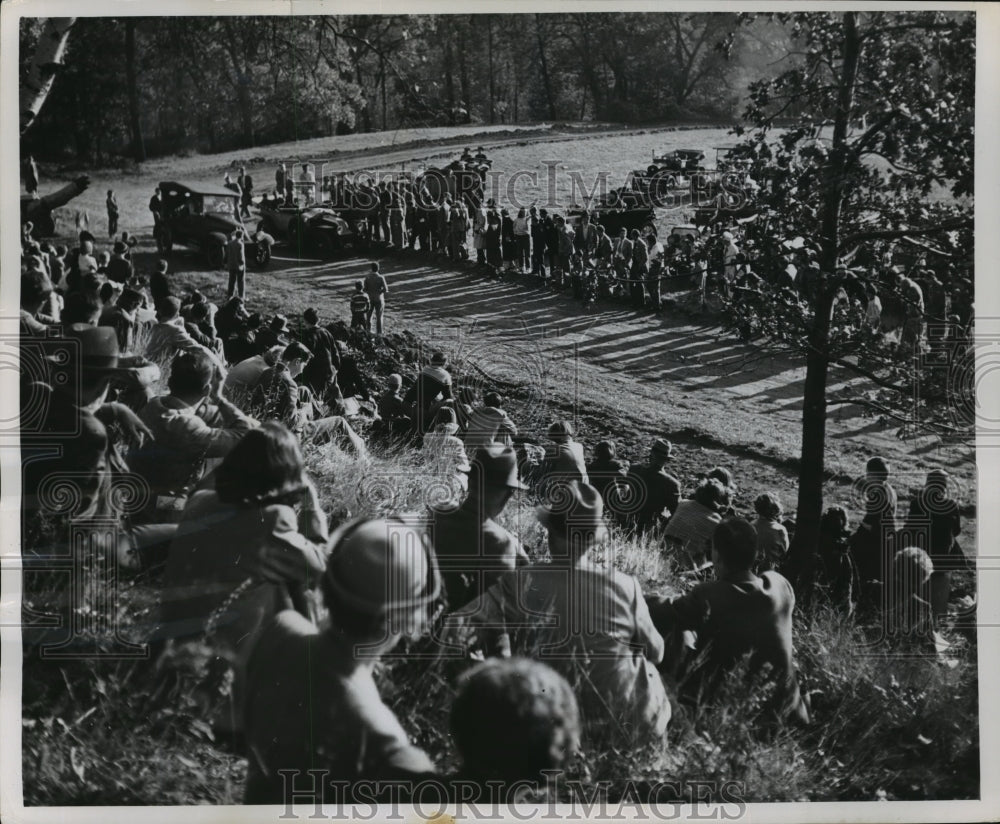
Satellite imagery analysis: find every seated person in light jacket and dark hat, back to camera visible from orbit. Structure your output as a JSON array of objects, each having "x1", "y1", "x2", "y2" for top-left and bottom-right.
[{"x1": 461, "y1": 480, "x2": 671, "y2": 747}]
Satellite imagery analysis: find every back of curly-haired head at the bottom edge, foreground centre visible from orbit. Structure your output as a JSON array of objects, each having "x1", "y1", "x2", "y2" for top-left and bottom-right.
[{"x1": 449, "y1": 658, "x2": 580, "y2": 800}]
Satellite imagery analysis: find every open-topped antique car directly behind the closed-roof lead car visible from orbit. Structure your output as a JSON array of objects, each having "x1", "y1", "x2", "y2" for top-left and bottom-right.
[{"x1": 258, "y1": 198, "x2": 367, "y2": 257}]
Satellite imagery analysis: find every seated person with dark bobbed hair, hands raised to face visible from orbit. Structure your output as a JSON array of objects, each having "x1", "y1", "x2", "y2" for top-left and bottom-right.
[{"x1": 153, "y1": 422, "x2": 328, "y2": 731}]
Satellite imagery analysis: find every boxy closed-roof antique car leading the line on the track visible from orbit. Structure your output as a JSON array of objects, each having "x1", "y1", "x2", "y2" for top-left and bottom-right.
[{"x1": 153, "y1": 181, "x2": 273, "y2": 269}]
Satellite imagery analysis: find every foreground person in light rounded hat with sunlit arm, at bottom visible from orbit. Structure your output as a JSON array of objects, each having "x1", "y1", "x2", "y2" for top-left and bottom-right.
[{"x1": 243, "y1": 518, "x2": 441, "y2": 804}]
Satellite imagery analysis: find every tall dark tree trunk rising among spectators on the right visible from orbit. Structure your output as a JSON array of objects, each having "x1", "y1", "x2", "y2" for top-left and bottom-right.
[{"x1": 789, "y1": 12, "x2": 861, "y2": 597}]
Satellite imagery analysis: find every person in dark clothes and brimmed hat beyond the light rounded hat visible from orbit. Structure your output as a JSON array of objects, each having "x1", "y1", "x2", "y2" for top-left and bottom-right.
[{"x1": 429, "y1": 446, "x2": 528, "y2": 610}]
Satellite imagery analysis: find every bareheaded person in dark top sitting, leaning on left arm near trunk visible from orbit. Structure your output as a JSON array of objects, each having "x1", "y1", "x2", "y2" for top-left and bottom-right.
[{"x1": 647, "y1": 517, "x2": 809, "y2": 723}]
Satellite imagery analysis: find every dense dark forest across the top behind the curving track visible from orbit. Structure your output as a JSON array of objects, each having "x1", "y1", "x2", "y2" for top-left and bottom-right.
[{"x1": 20, "y1": 13, "x2": 790, "y2": 165}]
